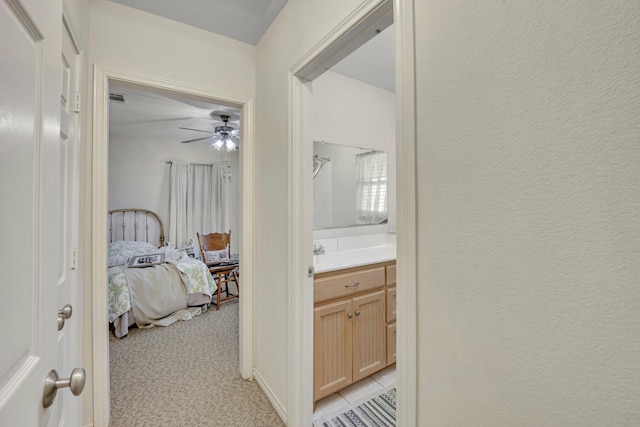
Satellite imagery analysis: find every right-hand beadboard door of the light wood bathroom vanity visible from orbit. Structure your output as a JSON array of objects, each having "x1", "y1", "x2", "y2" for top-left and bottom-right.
[{"x1": 352, "y1": 289, "x2": 387, "y2": 382}]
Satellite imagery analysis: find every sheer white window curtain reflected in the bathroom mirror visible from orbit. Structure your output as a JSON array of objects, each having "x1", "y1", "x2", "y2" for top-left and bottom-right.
[{"x1": 356, "y1": 151, "x2": 388, "y2": 224}]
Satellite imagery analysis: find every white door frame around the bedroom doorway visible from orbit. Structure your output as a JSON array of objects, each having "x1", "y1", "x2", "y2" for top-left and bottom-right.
[{"x1": 92, "y1": 69, "x2": 253, "y2": 424}]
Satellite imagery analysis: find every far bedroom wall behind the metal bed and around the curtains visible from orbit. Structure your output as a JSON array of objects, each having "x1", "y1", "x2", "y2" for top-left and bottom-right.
[{"x1": 108, "y1": 137, "x2": 240, "y2": 253}]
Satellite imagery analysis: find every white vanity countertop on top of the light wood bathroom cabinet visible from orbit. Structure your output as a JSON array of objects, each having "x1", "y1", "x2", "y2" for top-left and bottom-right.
[{"x1": 313, "y1": 245, "x2": 396, "y2": 273}]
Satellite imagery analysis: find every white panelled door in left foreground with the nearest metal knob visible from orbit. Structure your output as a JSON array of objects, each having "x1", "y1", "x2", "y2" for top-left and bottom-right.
[{"x1": 0, "y1": 0, "x2": 83, "y2": 426}]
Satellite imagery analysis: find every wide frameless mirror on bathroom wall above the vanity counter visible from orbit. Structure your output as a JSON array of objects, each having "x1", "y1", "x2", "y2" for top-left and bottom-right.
[{"x1": 313, "y1": 141, "x2": 389, "y2": 229}]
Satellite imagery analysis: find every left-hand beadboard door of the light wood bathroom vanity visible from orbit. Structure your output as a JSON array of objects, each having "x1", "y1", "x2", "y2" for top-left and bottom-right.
[{"x1": 313, "y1": 299, "x2": 355, "y2": 401}]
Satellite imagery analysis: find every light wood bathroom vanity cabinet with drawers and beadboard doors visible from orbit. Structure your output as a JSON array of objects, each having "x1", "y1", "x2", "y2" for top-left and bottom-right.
[{"x1": 313, "y1": 260, "x2": 396, "y2": 402}]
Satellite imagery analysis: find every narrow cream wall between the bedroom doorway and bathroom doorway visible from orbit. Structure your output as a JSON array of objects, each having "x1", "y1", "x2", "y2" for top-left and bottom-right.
[{"x1": 254, "y1": 0, "x2": 372, "y2": 414}]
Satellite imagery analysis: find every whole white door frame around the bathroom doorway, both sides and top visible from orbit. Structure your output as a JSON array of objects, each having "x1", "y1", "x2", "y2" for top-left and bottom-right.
[{"x1": 287, "y1": 0, "x2": 418, "y2": 426}]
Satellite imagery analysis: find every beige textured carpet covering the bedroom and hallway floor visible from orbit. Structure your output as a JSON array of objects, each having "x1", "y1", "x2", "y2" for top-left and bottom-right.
[{"x1": 109, "y1": 299, "x2": 284, "y2": 427}]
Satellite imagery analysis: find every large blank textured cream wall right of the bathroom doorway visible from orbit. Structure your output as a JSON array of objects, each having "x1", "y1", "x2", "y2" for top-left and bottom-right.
[{"x1": 415, "y1": 0, "x2": 640, "y2": 426}]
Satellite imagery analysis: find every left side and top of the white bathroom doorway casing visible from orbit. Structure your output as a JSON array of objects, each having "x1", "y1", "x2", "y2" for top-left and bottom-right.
[{"x1": 287, "y1": 0, "x2": 393, "y2": 426}]
